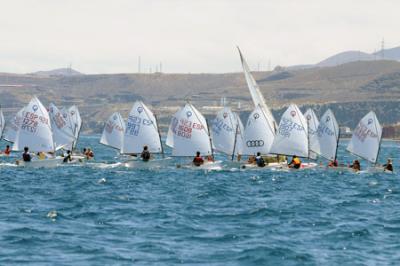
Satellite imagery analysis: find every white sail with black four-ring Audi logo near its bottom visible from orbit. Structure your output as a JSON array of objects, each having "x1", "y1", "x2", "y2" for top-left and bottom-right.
[{"x1": 243, "y1": 105, "x2": 275, "y2": 155}]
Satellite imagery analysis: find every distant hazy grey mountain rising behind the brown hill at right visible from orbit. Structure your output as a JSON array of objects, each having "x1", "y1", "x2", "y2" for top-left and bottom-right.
[{"x1": 316, "y1": 51, "x2": 375, "y2": 67}]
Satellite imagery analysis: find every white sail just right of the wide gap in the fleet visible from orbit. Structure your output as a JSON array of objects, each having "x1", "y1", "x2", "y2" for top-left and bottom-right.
[{"x1": 100, "y1": 112, "x2": 125, "y2": 150}]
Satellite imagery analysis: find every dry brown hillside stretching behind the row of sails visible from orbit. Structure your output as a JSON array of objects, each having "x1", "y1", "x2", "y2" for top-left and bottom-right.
[{"x1": 0, "y1": 61, "x2": 400, "y2": 132}]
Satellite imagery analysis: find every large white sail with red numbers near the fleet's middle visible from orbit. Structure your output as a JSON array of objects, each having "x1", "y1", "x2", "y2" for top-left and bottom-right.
[{"x1": 170, "y1": 103, "x2": 212, "y2": 156}]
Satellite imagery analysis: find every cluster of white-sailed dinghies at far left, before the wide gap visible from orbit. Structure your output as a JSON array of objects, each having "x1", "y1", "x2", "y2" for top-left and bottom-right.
[{"x1": 0, "y1": 97, "x2": 82, "y2": 167}]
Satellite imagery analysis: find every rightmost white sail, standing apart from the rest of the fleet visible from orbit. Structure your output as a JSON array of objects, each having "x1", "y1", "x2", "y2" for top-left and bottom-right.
[{"x1": 347, "y1": 111, "x2": 382, "y2": 163}]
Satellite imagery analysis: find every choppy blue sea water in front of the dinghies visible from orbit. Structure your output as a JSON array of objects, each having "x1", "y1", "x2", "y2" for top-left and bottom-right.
[{"x1": 0, "y1": 136, "x2": 400, "y2": 265}]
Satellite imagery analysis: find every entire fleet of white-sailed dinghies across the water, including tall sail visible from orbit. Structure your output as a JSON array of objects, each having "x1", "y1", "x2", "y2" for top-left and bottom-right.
[{"x1": 0, "y1": 48, "x2": 390, "y2": 170}]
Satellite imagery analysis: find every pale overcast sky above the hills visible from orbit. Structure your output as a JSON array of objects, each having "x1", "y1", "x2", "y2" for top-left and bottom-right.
[{"x1": 0, "y1": 0, "x2": 400, "y2": 74}]
